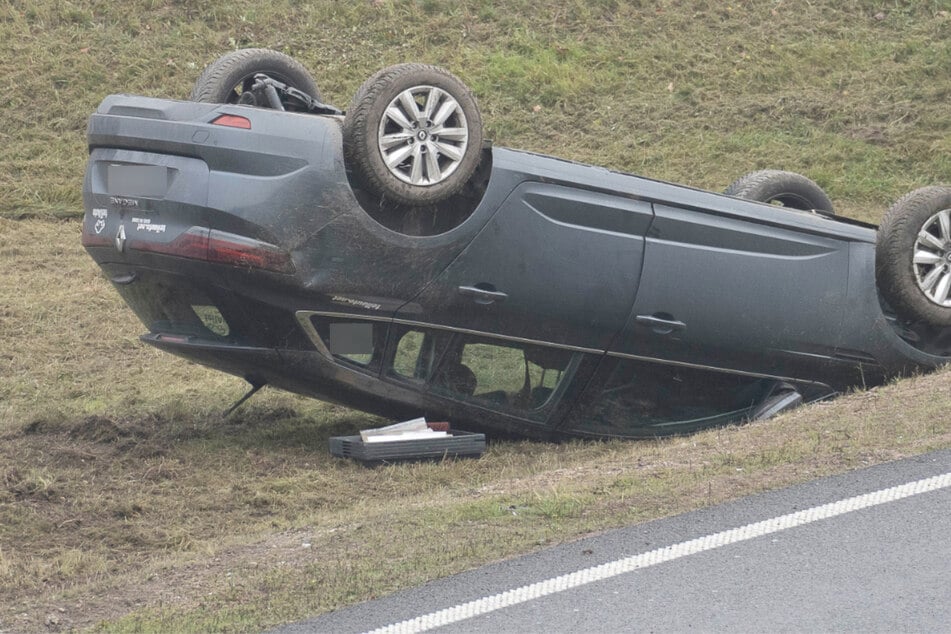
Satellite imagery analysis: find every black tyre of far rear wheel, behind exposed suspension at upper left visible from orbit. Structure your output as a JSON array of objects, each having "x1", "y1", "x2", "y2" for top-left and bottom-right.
[{"x1": 189, "y1": 48, "x2": 320, "y2": 105}]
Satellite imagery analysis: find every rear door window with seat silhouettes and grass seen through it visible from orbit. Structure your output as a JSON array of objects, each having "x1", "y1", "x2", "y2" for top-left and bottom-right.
[{"x1": 432, "y1": 336, "x2": 575, "y2": 411}]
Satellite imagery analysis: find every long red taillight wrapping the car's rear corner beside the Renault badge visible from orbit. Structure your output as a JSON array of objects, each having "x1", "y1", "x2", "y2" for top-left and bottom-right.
[{"x1": 129, "y1": 227, "x2": 294, "y2": 273}]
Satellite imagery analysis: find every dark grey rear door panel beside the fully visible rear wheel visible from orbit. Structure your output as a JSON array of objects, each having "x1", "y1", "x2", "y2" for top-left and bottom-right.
[{"x1": 396, "y1": 182, "x2": 652, "y2": 351}]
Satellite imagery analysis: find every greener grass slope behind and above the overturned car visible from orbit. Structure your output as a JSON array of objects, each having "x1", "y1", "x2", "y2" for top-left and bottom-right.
[{"x1": 0, "y1": 0, "x2": 951, "y2": 221}]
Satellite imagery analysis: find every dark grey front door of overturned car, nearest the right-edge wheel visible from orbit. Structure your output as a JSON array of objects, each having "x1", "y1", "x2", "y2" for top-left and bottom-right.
[{"x1": 611, "y1": 203, "x2": 849, "y2": 378}]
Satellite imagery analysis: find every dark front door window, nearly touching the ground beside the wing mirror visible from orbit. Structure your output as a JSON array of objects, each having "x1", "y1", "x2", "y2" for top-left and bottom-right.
[{"x1": 571, "y1": 359, "x2": 773, "y2": 436}]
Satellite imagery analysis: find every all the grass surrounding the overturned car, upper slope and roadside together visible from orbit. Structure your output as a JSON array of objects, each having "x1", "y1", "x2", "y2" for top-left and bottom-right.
[{"x1": 0, "y1": 0, "x2": 951, "y2": 632}]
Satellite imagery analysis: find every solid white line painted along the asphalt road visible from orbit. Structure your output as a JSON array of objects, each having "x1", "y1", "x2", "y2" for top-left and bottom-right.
[{"x1": 369, "y1": 473, "x2": 951, "y2": 634}]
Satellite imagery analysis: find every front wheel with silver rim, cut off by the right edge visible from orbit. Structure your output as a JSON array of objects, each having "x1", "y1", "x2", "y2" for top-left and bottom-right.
[{"x1": 875, "y1": 186, "x2": 951, "y2": 327}]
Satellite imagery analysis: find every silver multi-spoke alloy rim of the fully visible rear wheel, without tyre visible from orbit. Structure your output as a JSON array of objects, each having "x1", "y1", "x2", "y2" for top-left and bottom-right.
[{"x1": 377, "y1": 86, "x2": 469, "y2": 187}]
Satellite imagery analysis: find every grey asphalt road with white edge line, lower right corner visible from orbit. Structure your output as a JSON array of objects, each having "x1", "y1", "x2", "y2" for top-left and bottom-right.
[{"x1": 276, "y1": 451, "x2": 951, "y2": 634}]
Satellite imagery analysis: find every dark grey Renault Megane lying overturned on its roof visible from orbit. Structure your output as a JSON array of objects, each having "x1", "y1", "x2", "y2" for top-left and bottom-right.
[{"x1": 82, "y1": 49, "x2": 951, "y2": 438}]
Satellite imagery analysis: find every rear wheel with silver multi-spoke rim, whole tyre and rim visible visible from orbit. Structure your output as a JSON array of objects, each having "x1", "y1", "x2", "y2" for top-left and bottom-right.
[{"x1": 343, "y1": 64, "x2": 482, "y2": 206}]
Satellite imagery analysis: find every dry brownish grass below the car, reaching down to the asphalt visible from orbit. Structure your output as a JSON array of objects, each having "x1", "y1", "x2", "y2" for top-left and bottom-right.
[{"x1": 0, "y1": 219, "x2": 951, "y2": 631}]
